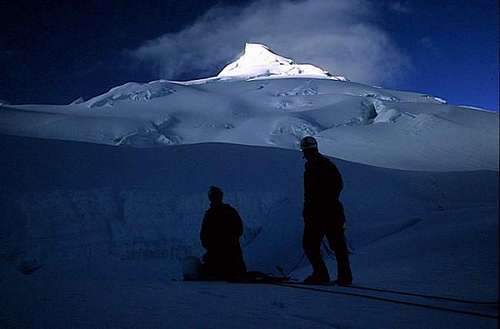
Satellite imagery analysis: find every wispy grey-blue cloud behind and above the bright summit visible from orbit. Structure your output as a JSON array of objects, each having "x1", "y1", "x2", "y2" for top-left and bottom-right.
[{"x1": 130, "y1": 0, "x2": 408, "y2": 83}]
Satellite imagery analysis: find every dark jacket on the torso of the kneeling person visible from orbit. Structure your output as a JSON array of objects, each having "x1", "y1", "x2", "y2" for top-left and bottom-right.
[{"x1": 200, "y1": 203, "x2": 243, "y2": 257}]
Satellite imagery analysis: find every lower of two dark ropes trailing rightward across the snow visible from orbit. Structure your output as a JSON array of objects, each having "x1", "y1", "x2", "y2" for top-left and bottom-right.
[{"x1": 272, "y1": 282, "x2": 498, "y2": 319}]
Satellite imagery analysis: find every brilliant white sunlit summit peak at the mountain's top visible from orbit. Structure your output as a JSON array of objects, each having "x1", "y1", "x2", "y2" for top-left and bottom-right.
[{"x1": 217, "y1": 43, "x2": 347, "y2": 81}]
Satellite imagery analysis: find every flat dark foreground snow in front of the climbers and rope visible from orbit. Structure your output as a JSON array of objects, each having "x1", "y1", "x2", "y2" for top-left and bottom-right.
[{"x1": 0, "y1": 264, "x2": 497, "y2": 329}]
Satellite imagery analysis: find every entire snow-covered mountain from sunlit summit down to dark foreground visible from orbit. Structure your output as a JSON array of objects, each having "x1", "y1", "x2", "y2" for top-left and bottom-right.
[{"x1": 0, "y1": 44, "x2": 499, "y2": 329}]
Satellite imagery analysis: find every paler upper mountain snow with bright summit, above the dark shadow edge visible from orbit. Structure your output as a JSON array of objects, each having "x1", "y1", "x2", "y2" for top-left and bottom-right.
[{"x1": 0, "y1": 44, "x2": 499, "y2": 171}]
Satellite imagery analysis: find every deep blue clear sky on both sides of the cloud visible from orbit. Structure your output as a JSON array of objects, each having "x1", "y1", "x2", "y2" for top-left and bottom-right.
[{"x1": 0, "y1": 0, "x2": 498, "y2": 111}]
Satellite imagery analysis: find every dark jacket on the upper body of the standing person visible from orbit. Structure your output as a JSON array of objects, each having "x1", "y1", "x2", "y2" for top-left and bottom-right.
[{"x1": 303, "y1": 154, "x2": 345, "y2": 222}]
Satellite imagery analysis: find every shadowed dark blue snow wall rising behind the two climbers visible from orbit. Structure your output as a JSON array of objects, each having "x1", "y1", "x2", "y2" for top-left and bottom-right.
[{"x1": 0, "y1": 136, "x2": 498, "y2": 274}]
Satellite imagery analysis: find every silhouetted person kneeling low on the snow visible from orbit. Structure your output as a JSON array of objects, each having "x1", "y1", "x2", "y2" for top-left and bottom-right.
[{"x1": 200, "y1": 186, "x2": 246, "y2": 280}]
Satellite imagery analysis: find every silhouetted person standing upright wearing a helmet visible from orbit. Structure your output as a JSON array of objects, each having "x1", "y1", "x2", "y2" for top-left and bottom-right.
[{"x1": 300, "y1": 136, "x2": 352, "y2": 285}]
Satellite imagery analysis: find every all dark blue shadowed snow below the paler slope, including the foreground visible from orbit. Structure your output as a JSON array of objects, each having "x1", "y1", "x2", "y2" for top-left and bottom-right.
[{"x1": 0, "y1": 136, "x2": 499, "y2": 328}]
